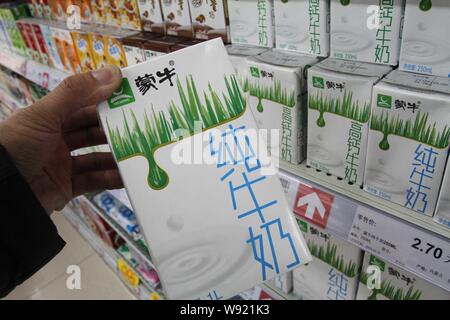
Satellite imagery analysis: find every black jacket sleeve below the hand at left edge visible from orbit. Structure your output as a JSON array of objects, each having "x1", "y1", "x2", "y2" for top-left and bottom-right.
[{"x1": 0, "y1": 145, "x2": 65, "y2": 298}]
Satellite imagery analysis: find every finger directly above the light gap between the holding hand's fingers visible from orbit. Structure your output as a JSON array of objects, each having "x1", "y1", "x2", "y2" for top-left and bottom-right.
[{"x1": 64, "y1": 127, "x2": 107, "y2": 151}]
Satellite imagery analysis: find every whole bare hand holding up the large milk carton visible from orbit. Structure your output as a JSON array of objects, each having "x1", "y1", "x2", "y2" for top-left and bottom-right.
[{"x1": 0, "y1": 66, "x2": 122, "y2": 213}]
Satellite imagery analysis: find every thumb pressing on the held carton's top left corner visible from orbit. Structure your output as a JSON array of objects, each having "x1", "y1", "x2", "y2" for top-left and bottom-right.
[{"x1": 30, "y1": 65, "x2": 122, "y2": 128}]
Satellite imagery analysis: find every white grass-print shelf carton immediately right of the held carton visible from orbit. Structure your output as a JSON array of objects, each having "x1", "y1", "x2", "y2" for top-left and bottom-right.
[{"x1": 243, "y1": 50, "x2": 318, "y2": 164}]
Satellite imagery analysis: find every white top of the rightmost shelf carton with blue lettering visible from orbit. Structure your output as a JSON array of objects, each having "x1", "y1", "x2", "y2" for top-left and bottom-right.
[{"x1": 382, "y1": 70, "x2": 450, "y2": 95}]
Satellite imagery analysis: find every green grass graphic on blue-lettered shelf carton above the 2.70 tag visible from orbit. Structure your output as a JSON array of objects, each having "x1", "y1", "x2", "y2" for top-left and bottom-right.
[{"x1": 370, "y1": 111, "x2": 450, "y2": 150}]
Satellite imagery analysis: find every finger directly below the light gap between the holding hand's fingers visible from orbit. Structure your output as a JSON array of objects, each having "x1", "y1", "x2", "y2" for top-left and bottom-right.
[{"x1": 72, "y1": 152, "x2": 117, "y2": 175}]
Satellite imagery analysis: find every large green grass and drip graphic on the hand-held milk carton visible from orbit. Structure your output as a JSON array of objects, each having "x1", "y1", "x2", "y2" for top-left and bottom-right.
[{"x1": 107, "y1": 75, "x2": 246, "y2": 190}]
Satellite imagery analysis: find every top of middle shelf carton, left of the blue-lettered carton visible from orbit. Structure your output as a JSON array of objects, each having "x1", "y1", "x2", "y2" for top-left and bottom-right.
[{"x1": 316, "y1": 58, "x2": 392, "y2": 78}]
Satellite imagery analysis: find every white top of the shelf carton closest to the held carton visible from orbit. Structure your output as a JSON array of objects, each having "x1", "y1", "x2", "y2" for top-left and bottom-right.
[{"x1": 253, "y1": 49, "x2": 319, "y2": 68}]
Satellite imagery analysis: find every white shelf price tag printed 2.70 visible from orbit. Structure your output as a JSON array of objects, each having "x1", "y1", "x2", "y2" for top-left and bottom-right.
[{"x1": 348, "y1": 206, "x2": 450, "y2": 291}]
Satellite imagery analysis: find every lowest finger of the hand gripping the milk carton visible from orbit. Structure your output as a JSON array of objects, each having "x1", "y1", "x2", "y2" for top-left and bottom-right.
[{"x1": 72, "y1": 169, "x2": 123, "y2": 197}]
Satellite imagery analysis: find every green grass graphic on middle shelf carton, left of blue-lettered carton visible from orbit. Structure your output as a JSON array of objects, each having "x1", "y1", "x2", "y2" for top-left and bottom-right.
[{"x1": 308, "y1": 91, "x2": 370, "y2": 127}]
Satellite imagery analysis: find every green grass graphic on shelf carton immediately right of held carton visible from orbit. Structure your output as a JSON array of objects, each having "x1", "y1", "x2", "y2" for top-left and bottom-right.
[{"x1": 242, "y1": 78, "x2": 296, "y2": 112}]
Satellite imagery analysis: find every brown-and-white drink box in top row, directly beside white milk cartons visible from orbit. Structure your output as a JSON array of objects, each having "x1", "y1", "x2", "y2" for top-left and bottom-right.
[{"x1": 189, "y1": 0, "x2": 230, "y2": 43}]
